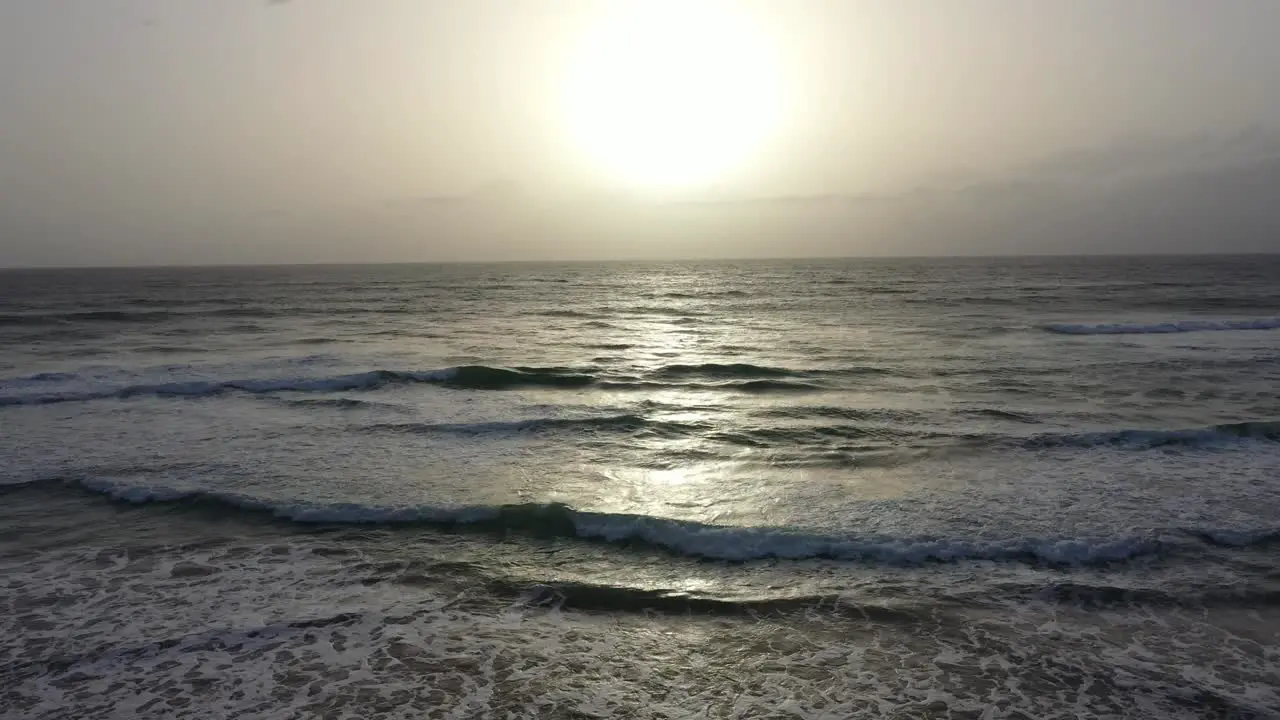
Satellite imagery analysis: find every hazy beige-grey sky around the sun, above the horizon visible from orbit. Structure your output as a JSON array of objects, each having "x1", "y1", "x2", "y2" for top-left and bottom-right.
[{"x1": 0, "y1": 0, "x2": 1280, "y2": 265}]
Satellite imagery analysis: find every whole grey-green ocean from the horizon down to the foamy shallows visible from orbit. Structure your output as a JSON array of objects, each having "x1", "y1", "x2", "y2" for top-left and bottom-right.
[{"x1": 0, "y1": 256, "x2": 1280, "y2": 719}]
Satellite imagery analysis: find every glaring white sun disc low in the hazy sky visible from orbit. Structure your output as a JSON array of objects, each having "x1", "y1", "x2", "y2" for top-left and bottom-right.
[{"x1": 566, "y1": 0, "x2": 782, "y2": 190}]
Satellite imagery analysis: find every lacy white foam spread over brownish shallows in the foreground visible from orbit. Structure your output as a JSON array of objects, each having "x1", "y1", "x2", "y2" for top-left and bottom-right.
[{"x1": 0, "y1": 520, "x2": 1280, "y2": 720}]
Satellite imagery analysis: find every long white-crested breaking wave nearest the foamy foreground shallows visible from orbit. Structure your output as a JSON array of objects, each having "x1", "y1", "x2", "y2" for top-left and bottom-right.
[{"x1": 9, "y1": 478, "x2": 1280, "y2": 565}]
